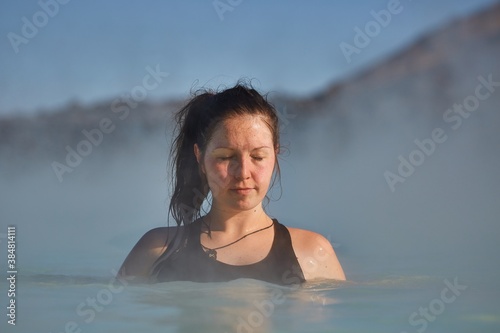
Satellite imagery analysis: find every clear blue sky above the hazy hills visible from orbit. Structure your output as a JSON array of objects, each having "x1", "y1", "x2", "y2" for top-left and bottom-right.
[{"x1": 0, "y1": 0, "x2": 496, "y2": 116}]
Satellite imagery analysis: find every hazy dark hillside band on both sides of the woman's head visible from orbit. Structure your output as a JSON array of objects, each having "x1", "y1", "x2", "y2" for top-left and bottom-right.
[{"x1": 0, "y1": 4, "x2": 500, "y2": 162}]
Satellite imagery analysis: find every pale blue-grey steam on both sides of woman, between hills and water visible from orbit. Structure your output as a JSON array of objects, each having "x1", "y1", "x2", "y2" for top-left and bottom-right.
[{"x1": 0, "y1": 97, "x2": 500, "y2": 280}]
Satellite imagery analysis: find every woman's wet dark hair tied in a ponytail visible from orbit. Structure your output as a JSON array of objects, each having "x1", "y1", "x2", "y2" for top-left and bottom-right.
[{"x1": 150, "y1": 82, "x2": 280, "y2": 270}]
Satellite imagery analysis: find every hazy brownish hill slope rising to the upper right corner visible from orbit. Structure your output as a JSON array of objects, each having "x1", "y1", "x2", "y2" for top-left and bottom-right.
[{"x1": 282, "y1": 4, "x2": 500, "y2": 150}]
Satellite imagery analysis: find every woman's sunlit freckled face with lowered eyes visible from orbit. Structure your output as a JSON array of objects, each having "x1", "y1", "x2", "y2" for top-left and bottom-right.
[{"x1": 195, "y1": 115, "x2": 276, "y2": 211}]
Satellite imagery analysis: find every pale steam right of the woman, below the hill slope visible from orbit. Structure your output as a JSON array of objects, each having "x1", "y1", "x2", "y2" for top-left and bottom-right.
[{"x1": 278, "y1": 105, "x2": 500, "y2": 276}]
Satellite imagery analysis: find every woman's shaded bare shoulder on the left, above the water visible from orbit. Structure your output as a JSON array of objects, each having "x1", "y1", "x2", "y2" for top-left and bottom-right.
[{"x1": 118, "y1": 227, "x2": 179, "y2": 279}]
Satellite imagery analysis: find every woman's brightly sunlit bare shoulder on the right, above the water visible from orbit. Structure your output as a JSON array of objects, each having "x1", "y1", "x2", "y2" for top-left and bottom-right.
[{"x1": 288, "y1": 228, "x2": 345, "y2": 281}]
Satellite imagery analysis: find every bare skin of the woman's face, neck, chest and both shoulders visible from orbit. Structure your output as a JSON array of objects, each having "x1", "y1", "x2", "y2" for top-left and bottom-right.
[{"x1": 119, "y1": 115, "x2": 345, "y2": 280}]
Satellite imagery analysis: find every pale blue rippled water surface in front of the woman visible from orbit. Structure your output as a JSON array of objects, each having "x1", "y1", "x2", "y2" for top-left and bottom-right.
[{"x1": 2, "y1": 275, "x2": 500, "y2": 333}]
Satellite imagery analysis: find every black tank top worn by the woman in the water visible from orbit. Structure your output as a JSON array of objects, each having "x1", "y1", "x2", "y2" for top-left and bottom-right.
[{"x1": 157, "y1": 219, "x2": 305, "y2": 285}]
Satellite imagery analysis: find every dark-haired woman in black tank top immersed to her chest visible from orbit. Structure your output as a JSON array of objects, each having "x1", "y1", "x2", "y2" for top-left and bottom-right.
[{"x1": 119, "y1": 84, "x2": 345, "y2": 284}]
